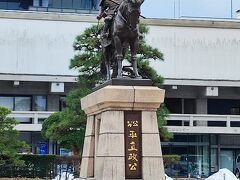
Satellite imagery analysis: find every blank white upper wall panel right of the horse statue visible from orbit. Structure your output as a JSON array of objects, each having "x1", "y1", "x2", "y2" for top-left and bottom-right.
[{"x1": 147, "y1": 26, "x2": 240, "y2": 80}]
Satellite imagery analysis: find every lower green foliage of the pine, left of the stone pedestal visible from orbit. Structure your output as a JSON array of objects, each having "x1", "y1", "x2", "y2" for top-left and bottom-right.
[{"x1": 42, "y1": 88, "x2": 90, "y2": 155}]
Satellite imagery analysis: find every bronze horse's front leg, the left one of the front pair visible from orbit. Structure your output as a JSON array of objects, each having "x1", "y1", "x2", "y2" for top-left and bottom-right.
[{"x1": 114, "y1": 36, "x2": 123, "y2": 78}]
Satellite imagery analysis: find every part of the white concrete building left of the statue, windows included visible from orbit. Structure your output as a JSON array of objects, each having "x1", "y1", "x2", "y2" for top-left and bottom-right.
[{"x1": 0, "y1": 0, "x2": 98, "y2": 153}]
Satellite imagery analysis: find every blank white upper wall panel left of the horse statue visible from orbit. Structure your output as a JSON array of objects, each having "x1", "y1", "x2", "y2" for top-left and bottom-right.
[{"x1": 0, "y1": 18, "x2": 94, "y2": 75}]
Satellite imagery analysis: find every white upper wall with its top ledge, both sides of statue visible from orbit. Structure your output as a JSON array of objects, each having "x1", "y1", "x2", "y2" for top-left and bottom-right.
[{"x1": 0, "y1": 13, "x2": 240, "y2": 80}]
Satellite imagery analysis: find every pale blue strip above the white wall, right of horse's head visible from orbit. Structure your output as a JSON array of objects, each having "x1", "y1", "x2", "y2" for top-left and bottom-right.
[{"x1": 142, "y1": 0, "x2": 240, "y2": 18}]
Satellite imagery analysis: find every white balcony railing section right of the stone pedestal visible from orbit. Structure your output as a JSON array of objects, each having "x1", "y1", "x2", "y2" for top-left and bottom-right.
[{"x1": 167, "y1": 114, "x2": 240, "y2": 134}]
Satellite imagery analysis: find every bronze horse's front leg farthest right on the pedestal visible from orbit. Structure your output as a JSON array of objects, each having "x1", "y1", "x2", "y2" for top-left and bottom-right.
[{"x1": 130, "y1": 38, "x2": 142, "y2": 79}]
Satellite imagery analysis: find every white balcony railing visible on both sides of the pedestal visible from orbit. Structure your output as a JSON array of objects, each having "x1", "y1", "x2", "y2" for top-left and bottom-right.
[{"x1": 9, "y1": 111, "x2": 240, "y2": 134}]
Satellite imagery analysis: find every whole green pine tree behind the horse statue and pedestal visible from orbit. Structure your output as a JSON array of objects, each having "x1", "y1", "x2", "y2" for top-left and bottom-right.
[{"x1": 42, "y1": 24, "x2": 171, "y2": 155}]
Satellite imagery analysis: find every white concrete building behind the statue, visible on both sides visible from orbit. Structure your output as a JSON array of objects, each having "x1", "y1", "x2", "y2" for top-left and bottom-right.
[{"x1": 0, "y1": 0, "x2": 240, "y2": 177}]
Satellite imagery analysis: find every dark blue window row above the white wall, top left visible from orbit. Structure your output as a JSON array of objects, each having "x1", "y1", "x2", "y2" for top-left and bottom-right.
[{"x1": 0, "y1": 0, "x2": 99, "y2": 10}]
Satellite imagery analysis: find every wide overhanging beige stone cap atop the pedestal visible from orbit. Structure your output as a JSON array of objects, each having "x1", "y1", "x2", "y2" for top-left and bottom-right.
[{"x1": 81, "y1": 86, "x2": 165, "y2": 114}]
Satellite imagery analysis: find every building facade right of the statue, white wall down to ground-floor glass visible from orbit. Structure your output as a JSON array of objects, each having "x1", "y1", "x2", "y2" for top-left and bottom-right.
[{"x1": 147, "y1": 19, "x2": 240, "y2": 177}]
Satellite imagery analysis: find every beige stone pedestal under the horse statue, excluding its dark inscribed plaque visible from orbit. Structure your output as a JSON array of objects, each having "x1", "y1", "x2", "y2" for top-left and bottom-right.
[{"x1": 80, "y1": 85, "x2": 165, "y2": 180}]
